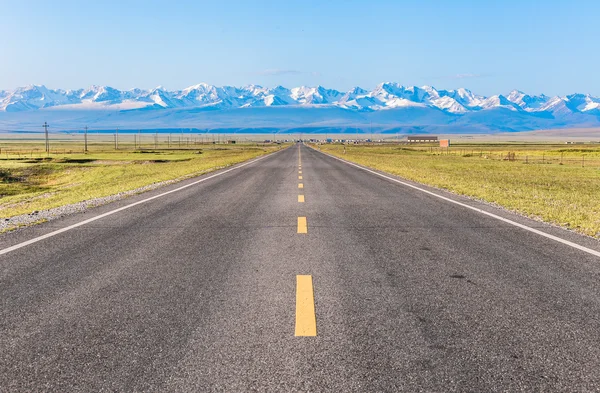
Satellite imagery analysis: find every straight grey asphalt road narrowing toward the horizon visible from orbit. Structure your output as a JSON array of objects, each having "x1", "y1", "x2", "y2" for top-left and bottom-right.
[{"x1": 0, "y1": 145, "x2": 600, "y2": 392}]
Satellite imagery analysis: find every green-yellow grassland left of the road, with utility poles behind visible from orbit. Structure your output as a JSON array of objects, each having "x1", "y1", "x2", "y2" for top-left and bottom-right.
[{"x1": 0, "y1": 140, "x2": 281, "y2": 218}]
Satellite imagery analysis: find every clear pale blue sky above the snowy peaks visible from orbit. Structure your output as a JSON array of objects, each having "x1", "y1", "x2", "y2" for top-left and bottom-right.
[{"x1": 0, "y1": 0, "x2": 600, "y2": 95}]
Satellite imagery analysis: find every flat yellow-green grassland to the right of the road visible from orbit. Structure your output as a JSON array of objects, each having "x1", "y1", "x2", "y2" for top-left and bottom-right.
[{"x1": 319, "y1": 144, "x2": 600, "y2": 238}]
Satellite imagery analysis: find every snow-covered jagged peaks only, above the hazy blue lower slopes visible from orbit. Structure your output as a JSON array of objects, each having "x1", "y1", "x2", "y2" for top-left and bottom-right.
[{"x1": 0, "y1": 82, "x2": 600, "y2": 115}]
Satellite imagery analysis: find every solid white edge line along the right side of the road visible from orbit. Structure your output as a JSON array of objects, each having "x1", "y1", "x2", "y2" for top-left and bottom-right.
[{"x1": 313, "y1": 145, "x2": 600, "y2": 258}]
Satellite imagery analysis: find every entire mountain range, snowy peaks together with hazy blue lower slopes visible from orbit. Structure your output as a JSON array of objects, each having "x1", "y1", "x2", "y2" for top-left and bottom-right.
[{"x1": 0, "y1": 82, "x2": 600, "y2": 131}]
